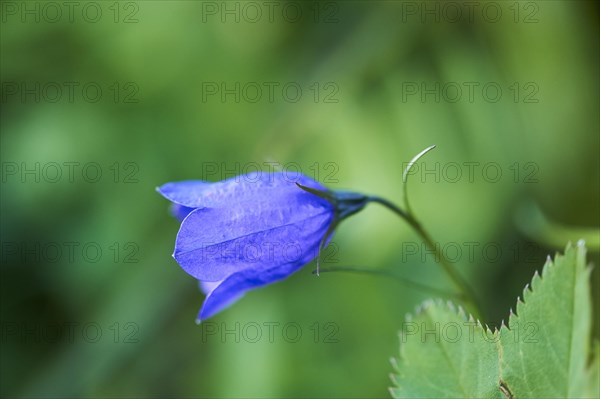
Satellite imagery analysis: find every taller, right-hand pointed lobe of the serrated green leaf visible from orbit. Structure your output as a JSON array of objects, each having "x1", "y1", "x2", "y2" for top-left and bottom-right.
[{"x1": 500, "y1": 243, "x2": 591, "y2": 398}]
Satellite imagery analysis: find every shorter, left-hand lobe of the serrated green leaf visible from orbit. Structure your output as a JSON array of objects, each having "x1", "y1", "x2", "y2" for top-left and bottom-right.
[{"x1": 390, "y1": 301, "x2": 502, "y2": 398}]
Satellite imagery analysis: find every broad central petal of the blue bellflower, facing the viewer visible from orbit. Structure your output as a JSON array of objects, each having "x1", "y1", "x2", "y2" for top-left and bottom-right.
[{"x1": 173, "y1": 191, "x2": 333, "y2": 281}]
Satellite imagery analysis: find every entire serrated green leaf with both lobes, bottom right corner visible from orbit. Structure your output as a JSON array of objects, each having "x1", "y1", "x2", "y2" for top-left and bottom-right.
[{"x1": 391, "y1": 243, "x2": 600, "y2": 398}]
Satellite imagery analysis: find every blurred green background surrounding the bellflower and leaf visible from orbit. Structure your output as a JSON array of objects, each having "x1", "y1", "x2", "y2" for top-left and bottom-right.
[{"x1": 0, "y1": 1, "x2": 600, "y2": 398}]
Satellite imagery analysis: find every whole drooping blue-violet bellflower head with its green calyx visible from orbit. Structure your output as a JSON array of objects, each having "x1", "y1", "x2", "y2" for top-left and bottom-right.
[{"x1": 157, "y1": 172, "x2": 366, "y2": 322}]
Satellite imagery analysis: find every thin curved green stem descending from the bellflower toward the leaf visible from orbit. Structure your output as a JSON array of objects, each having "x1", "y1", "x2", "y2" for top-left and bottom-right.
[{"x1": 369, "y1": 196, "x2": 483, "y2": 319}]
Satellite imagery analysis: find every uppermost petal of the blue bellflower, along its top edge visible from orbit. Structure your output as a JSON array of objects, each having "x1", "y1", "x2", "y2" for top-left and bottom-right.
[{"x1": 156, "y1": 172, "x2": 325, "y2": 208}]
